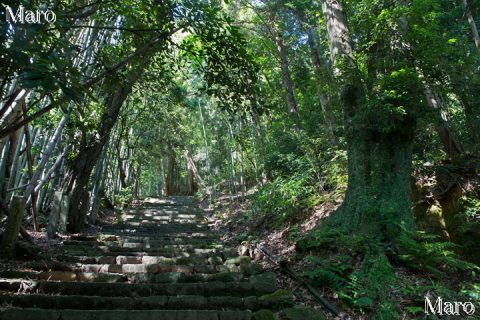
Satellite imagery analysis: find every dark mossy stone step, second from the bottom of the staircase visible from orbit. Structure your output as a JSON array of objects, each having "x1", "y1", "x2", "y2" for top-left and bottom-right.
[{"x1": 0, "y1": 294, "x2": 291, "y2": 311}]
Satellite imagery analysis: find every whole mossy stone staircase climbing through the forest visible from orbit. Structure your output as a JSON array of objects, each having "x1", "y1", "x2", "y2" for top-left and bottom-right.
[{"x1": 0, "y1": 197, "x2": 317, "y2": 320}]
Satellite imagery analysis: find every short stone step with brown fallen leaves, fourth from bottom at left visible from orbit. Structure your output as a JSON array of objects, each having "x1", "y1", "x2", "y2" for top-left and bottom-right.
[{"x1": 0, "y1": 271, "x2": 128, "y2": 282}]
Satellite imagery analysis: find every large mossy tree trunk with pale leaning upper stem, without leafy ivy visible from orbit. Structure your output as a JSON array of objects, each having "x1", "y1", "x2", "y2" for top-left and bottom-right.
[{"x1": 323, "y1": 0, "x2": 415, "y2": 243}]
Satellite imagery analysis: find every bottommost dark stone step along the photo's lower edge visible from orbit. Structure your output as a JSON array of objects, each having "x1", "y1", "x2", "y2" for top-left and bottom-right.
[{"x1": 0, "y1": 308, "x2": 252, "y2": 320}]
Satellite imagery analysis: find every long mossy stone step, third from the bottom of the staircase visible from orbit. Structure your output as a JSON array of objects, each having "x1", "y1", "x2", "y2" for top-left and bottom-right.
[{"x1": 0, "y1": 279, "x2": 276, "y2": 297}]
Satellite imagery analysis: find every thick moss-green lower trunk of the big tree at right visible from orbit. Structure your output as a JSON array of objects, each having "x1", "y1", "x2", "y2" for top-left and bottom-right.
[{"x1": 338, "y1": 127, "x2": 414, "y2": 242}]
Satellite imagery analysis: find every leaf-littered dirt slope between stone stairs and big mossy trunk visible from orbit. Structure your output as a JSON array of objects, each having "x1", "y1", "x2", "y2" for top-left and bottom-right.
[{"x1": 203, "y1": 192, "x2": 344, "y2": 319}]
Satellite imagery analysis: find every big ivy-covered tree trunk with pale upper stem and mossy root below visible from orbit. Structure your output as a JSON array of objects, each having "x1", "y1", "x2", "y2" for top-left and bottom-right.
[{"x1": 322, "y1": 0, "x2": 421, "y2": 319}]
